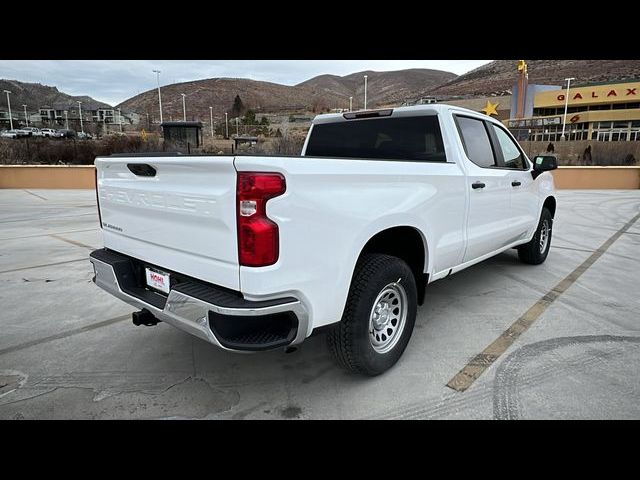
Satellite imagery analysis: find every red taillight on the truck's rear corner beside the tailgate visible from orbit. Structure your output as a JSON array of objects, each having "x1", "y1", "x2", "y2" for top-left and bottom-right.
[{"x1": 236, "y1": 172, "x2": 286, "y2": 267}]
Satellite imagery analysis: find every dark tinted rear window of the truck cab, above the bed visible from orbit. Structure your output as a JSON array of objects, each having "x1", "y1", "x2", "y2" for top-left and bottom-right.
[{"x1": 305, "y1": 115, "x2": 447, "y2": 162}]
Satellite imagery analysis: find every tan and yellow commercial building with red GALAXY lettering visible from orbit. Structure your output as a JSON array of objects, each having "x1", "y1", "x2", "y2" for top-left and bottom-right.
[{"x1": 504, "y1": 80, "x2": 640, "y2": 142}]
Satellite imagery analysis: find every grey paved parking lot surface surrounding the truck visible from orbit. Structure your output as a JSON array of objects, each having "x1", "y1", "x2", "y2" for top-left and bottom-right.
[{"x1": 0, "y1": 190, "x2": 640, "y2": 419}]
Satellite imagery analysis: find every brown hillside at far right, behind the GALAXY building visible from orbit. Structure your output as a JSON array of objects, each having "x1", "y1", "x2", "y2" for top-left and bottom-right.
[{"x1": 433, "y1": 60, "x2": 640, "y2": 96}]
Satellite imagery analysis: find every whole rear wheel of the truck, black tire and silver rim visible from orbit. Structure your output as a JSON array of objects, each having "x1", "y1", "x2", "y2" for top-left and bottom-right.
[{"x1": 327, "y1": 254, "x2": 417, "y2": 376}]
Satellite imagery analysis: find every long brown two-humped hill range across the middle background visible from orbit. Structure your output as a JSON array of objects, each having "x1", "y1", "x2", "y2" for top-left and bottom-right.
[{"x1": 118, "y1": 69, "x2": 455, "y2": 120}]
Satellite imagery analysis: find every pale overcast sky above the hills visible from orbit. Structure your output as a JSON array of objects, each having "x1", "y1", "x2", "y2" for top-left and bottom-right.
[{"x1": 0, "y1": 60, "x2": 490, "y2": 105}]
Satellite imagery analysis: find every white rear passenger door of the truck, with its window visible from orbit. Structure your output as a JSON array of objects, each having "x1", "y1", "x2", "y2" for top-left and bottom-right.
[{"x1": 455, "y1": 115, "x2": 512, "y2": 262}]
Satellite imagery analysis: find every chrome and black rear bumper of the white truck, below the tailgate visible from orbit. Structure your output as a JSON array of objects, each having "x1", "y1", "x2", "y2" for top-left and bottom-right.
[{"x1": 89, "y1": 249, "x2": 309, "y2": 351}]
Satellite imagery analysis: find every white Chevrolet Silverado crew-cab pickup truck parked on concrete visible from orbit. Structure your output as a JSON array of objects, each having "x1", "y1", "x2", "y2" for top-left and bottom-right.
[{"x1": 90, "y1": 105, "x2": 557, "y2": 375}]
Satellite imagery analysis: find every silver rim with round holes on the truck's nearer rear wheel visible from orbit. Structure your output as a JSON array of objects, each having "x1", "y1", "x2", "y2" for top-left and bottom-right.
[{"x1": 369, "y1": 282, "x2": 408, "y2": 353}]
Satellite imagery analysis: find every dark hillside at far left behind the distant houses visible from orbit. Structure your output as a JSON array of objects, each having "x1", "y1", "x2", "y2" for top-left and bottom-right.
[{"x1": 0, "y1": 79, "x2": 109, "y2": 112}]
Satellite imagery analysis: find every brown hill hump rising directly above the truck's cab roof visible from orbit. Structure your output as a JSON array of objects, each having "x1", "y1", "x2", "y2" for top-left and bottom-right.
[{"x1": 297, "y1": 68, "x2": 457, "y2": 108}]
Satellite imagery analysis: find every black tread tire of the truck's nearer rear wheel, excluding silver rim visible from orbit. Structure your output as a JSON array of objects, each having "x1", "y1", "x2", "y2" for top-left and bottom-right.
[{"x1": 327, "y1": 254, "x2": 418, "y2": 376}]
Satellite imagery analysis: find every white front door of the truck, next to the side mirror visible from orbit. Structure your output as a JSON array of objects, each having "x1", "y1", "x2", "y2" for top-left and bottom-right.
[{"x1": 489, "y1": 123, "x2": 539, "y2": 243}]
